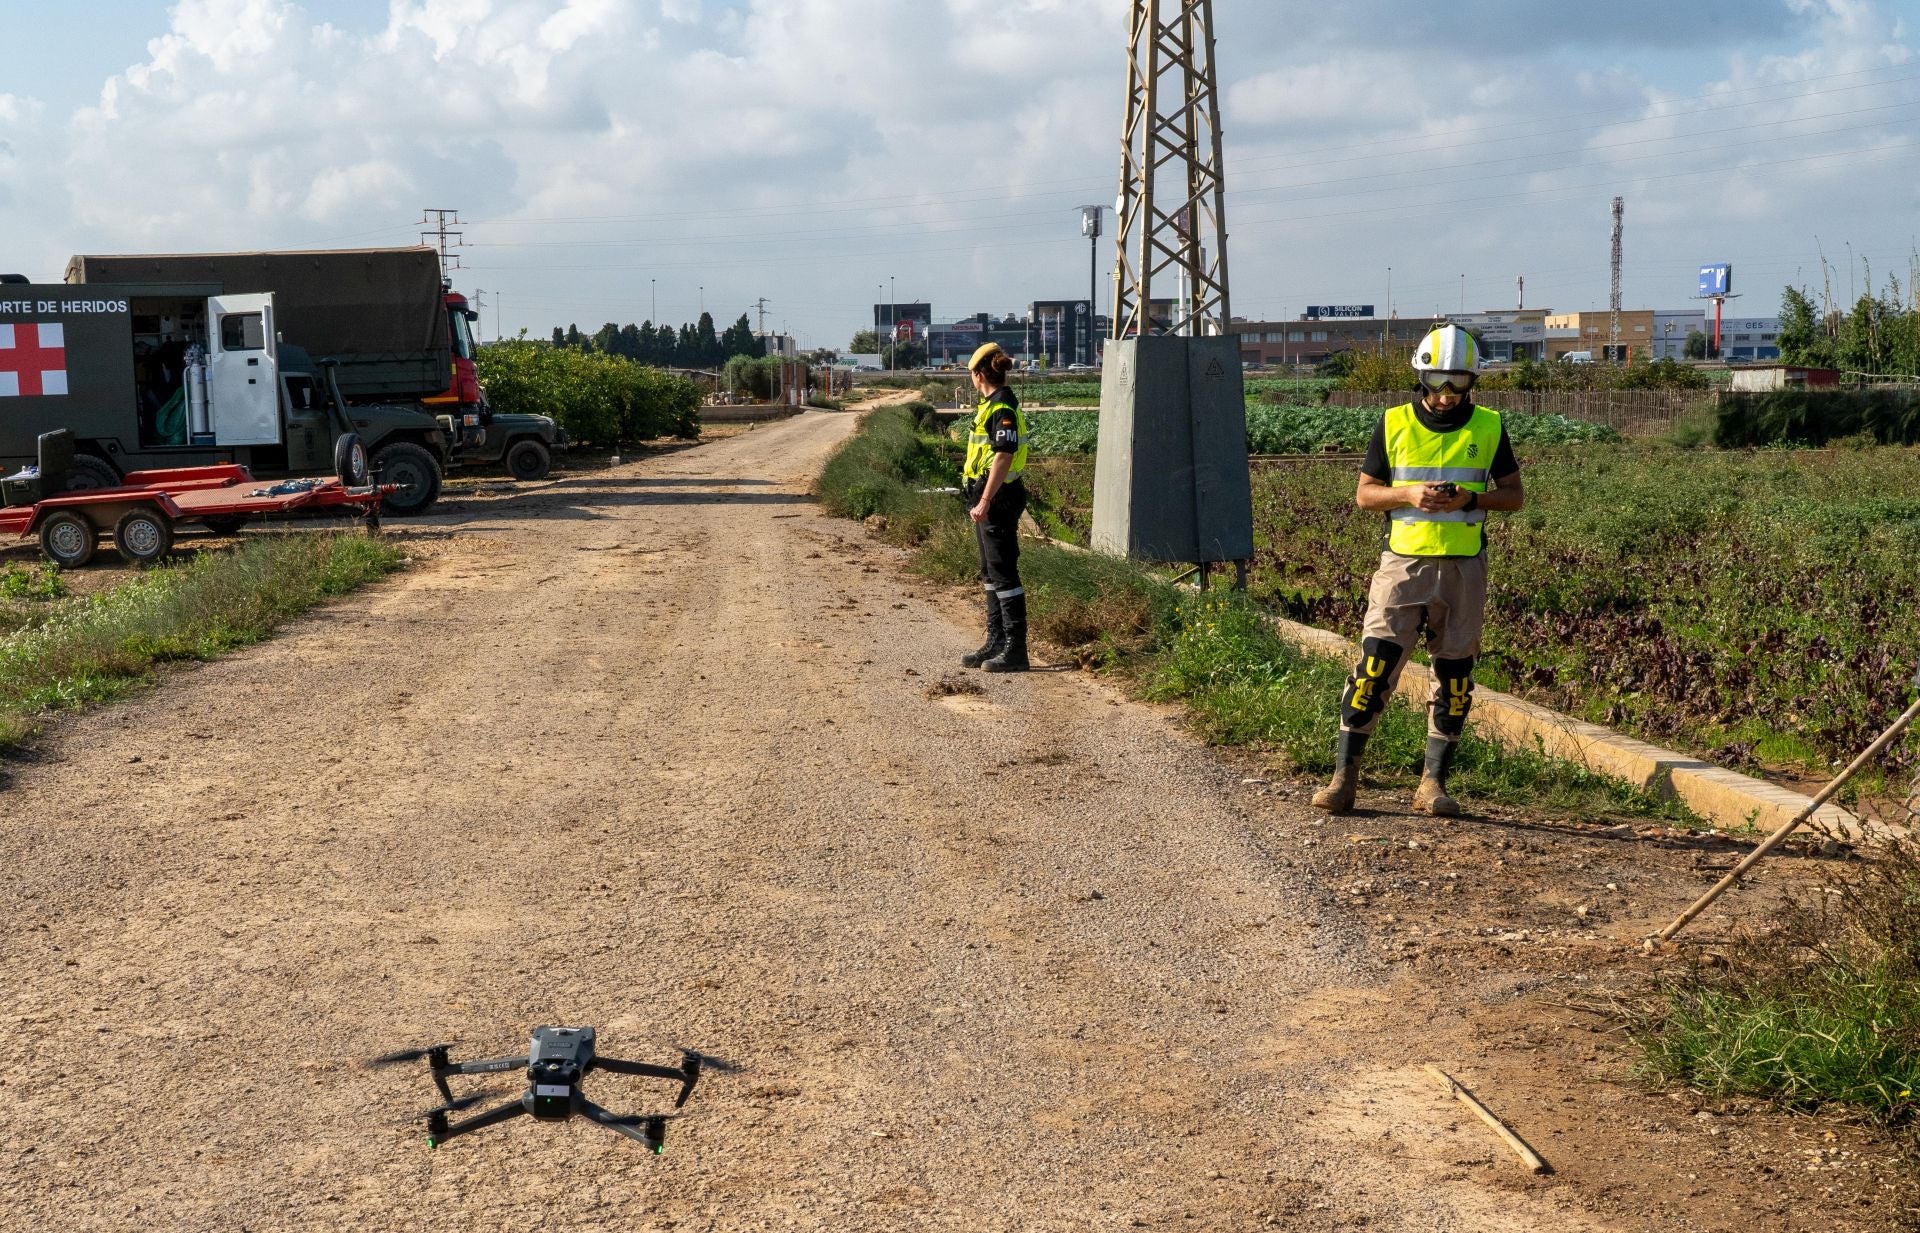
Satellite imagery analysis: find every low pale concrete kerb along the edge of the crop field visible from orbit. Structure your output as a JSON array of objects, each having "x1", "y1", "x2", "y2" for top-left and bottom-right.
[{"x1": 1033, "y1": 536, "x2": 1881, "y2": 841}]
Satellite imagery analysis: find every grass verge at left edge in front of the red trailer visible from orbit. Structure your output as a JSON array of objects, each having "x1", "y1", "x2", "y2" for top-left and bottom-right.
[{"x1": 0, "y1": 534, "x2": 401, "y2": 745}]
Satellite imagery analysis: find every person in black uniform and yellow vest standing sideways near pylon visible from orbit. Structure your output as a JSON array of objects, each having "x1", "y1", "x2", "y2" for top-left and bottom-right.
[{"x1": 960, "y1": 342, "x2": 1027, "y2": 672}]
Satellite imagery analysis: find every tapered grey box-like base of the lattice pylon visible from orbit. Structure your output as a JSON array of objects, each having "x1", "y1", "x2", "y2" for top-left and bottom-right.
[{"x1": 1092, "y1": 334, "x2": 1254, "y2": 563}]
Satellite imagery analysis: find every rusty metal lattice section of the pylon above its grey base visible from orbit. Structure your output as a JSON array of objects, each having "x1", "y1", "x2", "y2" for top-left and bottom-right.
[{"x1": 1112, "y1": 0, "x2": 1233, "y2": 338}]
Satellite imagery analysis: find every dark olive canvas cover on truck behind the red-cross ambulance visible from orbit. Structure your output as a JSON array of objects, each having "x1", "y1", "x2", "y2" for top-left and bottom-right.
[{"x1": 65, "y1": 246, "x2": 453, "y2": 399}]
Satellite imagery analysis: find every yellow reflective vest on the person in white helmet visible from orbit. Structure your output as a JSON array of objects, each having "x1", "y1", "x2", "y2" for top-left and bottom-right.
[{"x1": 1386, "y1": 403, "x2": 1500, "y2": 557}]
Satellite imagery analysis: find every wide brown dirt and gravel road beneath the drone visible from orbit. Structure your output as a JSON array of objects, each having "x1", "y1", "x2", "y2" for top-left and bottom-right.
[{"x1": 0, "y1": 403, "x2": 1904, "y2": 1231}]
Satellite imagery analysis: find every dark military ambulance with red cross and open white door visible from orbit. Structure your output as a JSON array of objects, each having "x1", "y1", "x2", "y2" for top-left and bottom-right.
[{"x1": 0, "y1": 275, "x2": 449, "y2": 515}]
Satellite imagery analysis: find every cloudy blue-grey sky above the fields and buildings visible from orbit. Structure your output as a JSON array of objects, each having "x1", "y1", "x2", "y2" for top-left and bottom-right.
[{"x1": 0, "y1": 0, "x2": 1920, "y2": 346}]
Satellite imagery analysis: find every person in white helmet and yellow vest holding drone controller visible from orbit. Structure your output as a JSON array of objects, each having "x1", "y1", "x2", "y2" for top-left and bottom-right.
[{"x1": 1313, "y1": 325, "x2": 1524, "y2": 816}]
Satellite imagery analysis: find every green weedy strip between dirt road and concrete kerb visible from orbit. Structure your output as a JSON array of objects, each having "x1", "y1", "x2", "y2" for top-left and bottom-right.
[{"x1": 818, "y1": 407, "x2": 1693, "y2": 822}]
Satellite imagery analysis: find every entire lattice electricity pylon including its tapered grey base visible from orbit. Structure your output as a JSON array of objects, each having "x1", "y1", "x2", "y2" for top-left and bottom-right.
[{"x1": 1092, "y1": 0, "x2": 1254, "y2": 586}]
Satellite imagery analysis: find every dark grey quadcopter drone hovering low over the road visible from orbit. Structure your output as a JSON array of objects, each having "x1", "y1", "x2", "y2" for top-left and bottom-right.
[{"x1": 372, "y1": 1028, "x2": 733, "y2": 1154}]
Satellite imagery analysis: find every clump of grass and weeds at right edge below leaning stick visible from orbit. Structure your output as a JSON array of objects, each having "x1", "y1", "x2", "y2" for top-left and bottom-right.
[{"x1": 1632, "y1": 845, "x2": 1920, "y2": 1125}]
